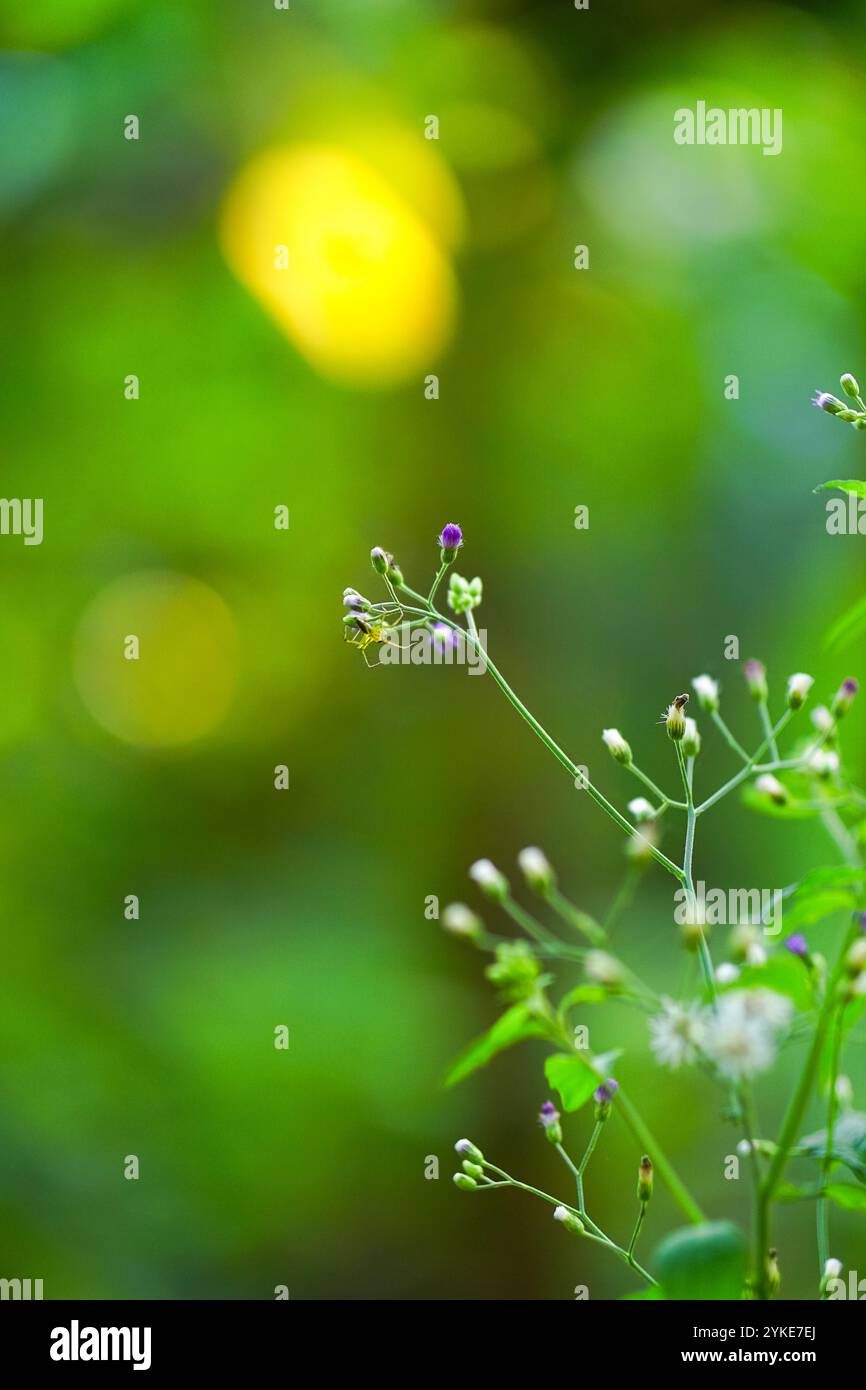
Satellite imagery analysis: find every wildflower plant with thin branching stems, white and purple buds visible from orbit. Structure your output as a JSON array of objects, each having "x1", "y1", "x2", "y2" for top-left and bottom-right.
[{"x1": 343, "y1": 525, "x2": 866, "y2": 1300}]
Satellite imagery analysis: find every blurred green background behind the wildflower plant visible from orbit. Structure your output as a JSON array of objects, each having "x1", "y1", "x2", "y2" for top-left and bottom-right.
[{"x1": 0, "y1": 0, "x2": 866, "y2": 1298}]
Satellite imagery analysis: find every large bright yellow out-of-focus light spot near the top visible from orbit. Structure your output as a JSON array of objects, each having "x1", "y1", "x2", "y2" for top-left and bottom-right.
[{"x1": 221, "y1": 145, "x2": 456, "y2": 385}]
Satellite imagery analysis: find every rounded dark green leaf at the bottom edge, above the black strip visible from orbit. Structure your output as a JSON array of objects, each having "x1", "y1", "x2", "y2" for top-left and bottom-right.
[{"x1": 653, "y1": 1220, "x2": 746, "y2": 1300}]
